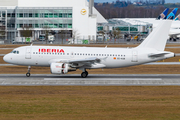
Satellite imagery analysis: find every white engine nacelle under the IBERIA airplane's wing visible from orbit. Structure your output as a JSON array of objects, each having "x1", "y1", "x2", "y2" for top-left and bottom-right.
[{"x1": 50, "y1": 63, "x2": 70, "y2": 74}]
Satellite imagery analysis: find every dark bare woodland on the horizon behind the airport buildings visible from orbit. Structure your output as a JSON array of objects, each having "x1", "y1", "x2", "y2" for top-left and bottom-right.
[{"x1": 95, "y1": 0, "x2": 165, "y2": 19}]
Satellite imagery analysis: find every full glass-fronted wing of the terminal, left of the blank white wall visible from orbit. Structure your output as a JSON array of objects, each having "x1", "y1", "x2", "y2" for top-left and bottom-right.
[{"x1": 0, "y1": 7, "x2": 73, "y2": 40}]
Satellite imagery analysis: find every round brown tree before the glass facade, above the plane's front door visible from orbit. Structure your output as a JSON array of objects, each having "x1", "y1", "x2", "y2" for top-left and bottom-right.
[{"x1": 20, "y1": 25, "x2": 32, "y2": 43}]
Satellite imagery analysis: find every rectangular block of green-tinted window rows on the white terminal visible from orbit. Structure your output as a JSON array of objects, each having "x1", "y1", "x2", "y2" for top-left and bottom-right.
[{"x1": 16, "y1": 7, "x2": 72, "y2": 28}]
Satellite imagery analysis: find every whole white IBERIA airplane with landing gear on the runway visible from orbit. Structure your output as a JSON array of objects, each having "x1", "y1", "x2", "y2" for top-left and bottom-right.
[{"x1": 3, "y1": 20, "x2": 175, "y2": 78}]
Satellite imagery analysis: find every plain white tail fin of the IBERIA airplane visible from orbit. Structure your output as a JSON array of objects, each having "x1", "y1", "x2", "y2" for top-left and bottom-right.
[{"x1": 137, "y1": 20, "x2": 172, "y2": 51}]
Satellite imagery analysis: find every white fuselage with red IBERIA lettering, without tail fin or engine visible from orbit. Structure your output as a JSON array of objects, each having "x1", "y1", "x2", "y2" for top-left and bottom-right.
[{"x1": 3, "y1": 46, "x2": 174, "y2": 68}]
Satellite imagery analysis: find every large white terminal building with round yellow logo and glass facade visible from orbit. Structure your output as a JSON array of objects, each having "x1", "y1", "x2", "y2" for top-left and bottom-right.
[{"x1": 0, "y1": 0, "x2": 107, "y2": 41}]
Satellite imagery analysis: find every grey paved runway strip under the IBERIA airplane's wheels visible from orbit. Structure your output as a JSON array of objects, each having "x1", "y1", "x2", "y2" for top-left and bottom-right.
[{"x1": 0, "y1": 74, "x2": 180, "y2": 86}]
